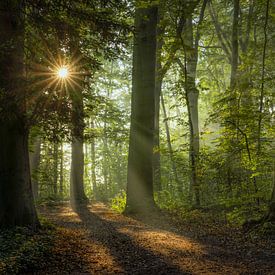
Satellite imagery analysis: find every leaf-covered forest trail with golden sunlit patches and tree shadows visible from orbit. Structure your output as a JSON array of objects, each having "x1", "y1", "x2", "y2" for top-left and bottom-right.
[{"x1": 41, "y1": 203, "x2": 275, "y2": 275}]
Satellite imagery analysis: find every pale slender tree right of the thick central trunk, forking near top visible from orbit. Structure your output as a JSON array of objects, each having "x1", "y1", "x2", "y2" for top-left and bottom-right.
[{"x1": 177, "y1": 0, "x2": 207, "y2": 207}]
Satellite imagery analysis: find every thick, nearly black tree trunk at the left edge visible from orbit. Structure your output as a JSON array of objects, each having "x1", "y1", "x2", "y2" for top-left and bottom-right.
[{"x1": 0, "y1": 0, "x2": 39, "y2": 228}]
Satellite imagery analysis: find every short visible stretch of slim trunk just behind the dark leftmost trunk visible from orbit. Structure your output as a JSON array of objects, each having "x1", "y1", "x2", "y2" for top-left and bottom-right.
[{"x1": 29, "y1": 136, "x2": 41, "y2": 200}]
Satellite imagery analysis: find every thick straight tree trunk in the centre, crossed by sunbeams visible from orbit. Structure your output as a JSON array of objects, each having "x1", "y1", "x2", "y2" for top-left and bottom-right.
[{"x1": 125, "y1": 1, "x2": 158, "y2": 213}]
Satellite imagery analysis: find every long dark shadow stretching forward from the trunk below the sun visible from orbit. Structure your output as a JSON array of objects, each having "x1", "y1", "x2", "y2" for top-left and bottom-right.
[{"x1": 76, "y1": 206, "x2": 191, "y2": 275}]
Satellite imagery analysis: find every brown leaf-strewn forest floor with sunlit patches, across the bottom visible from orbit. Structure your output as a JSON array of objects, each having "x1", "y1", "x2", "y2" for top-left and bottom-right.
[{"x1": 0, "y1": 203, "x2": 275, "y2": 275}]
